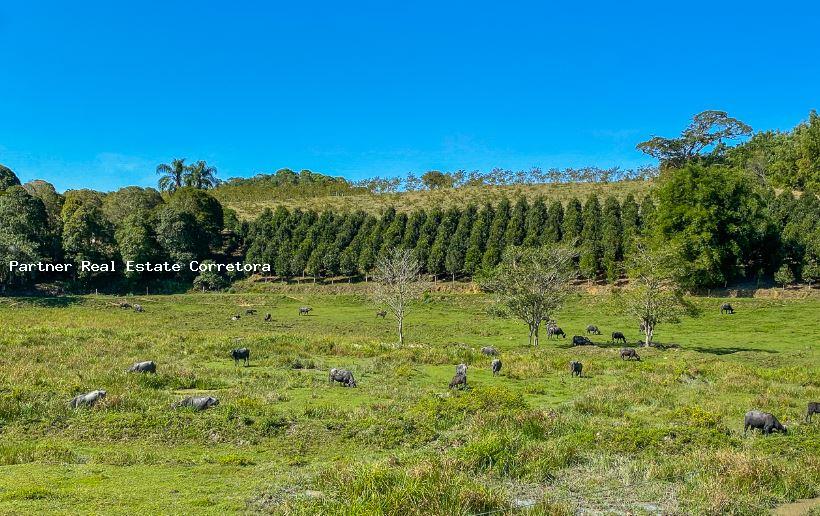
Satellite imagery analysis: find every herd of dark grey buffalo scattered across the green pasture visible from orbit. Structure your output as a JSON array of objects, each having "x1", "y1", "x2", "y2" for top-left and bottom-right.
[{"x1": 68, "y1": 303, "x2": 820, "y2": 435}]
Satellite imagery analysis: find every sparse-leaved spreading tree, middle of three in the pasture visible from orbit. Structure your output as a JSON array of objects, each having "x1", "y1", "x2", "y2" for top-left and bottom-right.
[{"x1": 479, "y1": 246, "x2": 577, "y2": 346}]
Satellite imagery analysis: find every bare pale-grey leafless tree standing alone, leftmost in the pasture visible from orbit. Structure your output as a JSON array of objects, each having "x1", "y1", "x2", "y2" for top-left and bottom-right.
[{"x1": 373, "y1": 248, "x2": 423, "y2": 345}]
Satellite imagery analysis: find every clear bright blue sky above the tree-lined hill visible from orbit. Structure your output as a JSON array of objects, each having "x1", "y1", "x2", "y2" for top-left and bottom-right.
[{"x1": 0, "y1": 1, "x2": 820, "y2": 190}]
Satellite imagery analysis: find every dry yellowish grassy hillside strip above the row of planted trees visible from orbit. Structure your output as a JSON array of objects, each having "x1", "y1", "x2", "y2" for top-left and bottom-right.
[{"x1": 212, "y1": 180, "x2": 652, "y2": 219}]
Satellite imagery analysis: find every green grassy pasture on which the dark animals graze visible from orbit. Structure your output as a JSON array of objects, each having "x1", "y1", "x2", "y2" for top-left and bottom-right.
[{"x1": 0, "y1": 285, "x2": 820, "y2": 514}]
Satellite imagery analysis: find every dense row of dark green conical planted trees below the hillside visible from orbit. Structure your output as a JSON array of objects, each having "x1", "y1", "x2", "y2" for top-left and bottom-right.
[{"x1": 246, "y1": 194, "x2": 654, "y2": 280}]
